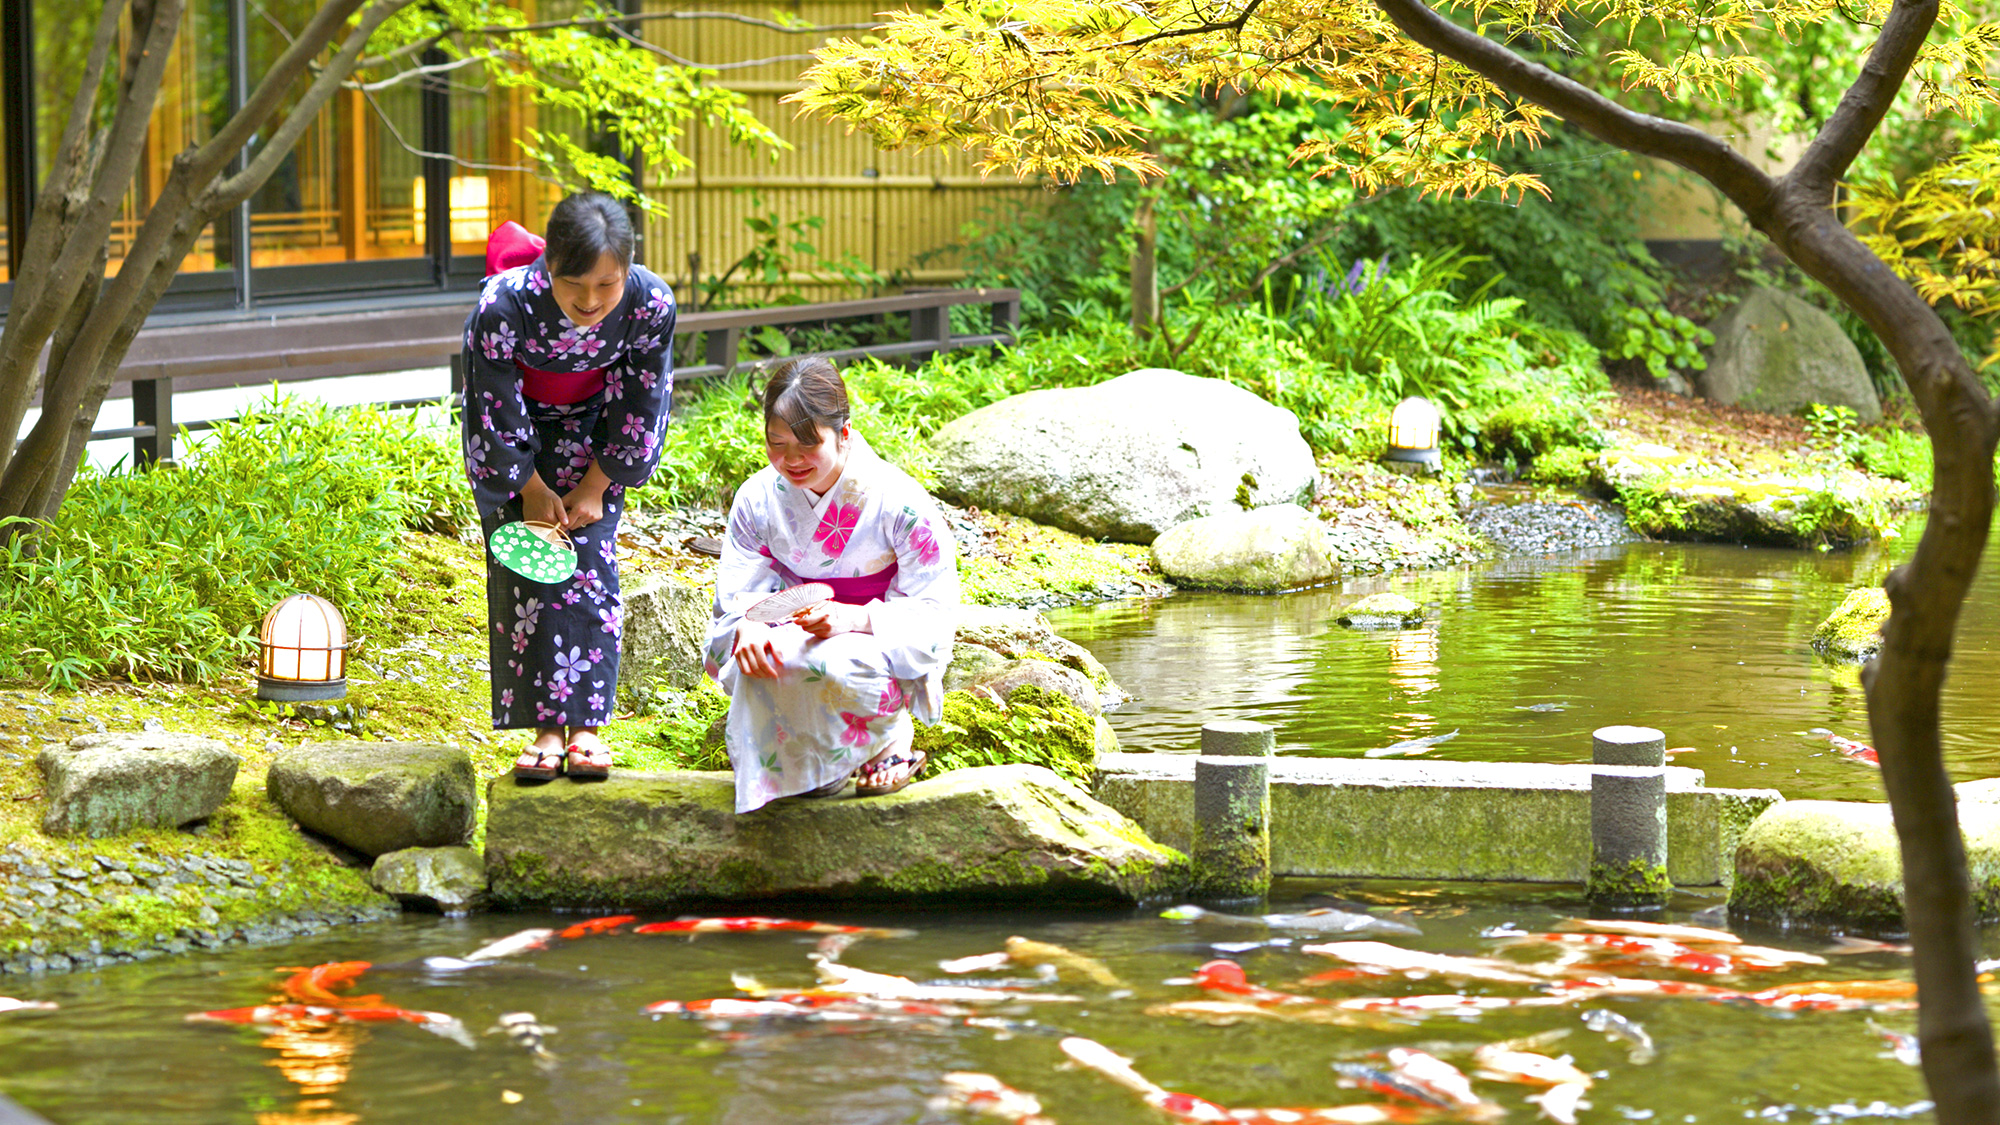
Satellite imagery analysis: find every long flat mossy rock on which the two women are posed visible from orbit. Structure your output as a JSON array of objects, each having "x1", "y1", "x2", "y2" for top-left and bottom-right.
[{"x1": 486, "y1": 765, "x2": 1188, "y2": 909}]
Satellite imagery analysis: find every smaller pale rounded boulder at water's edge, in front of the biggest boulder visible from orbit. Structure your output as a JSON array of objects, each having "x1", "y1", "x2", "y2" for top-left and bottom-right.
[{"x1": 1152, "y1": 504, "x2": 1340, "y2": 593}]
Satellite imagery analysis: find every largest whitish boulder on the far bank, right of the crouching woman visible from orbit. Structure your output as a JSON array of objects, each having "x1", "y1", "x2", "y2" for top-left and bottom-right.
[{"x1": 932, "y1": 368, "x2": 1314, "y2": 542}]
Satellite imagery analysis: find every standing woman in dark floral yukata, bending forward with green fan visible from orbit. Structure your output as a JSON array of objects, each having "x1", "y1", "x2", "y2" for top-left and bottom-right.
[{"x1": 464, "y1": 192, "x2": 674, "y2": 781}]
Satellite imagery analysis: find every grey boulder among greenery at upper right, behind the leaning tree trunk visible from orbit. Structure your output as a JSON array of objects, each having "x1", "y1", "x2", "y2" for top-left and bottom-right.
[{"x1": 1698, "y1": 288, "x2": 1882, "y2": 422}]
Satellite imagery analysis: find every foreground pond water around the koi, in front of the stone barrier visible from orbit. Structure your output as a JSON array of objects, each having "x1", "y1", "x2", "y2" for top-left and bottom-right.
[{"x1": 0, "y1": 881, "x2": 1960, "y2": 1125}]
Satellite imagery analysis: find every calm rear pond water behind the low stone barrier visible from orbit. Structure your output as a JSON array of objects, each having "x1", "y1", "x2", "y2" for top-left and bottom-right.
[{"x1": 1050, "y1": 508, "x2": 2000, "y2": 801}]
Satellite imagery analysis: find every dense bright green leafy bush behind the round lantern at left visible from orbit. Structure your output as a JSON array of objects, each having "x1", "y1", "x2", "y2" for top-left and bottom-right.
[{"x1": 0, "y1": 398, "x2": 460, "y2": 687}]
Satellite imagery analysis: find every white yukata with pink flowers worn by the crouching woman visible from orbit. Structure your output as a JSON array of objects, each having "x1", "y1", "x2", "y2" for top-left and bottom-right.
[{"x1": 704, "y1": 434, "x2": 958, "y2": 813}]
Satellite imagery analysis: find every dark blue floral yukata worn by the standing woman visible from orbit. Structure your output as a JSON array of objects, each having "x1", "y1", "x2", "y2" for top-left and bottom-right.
[{"x1": 464, "y1": 258, "x2": 674, "y2": 731}]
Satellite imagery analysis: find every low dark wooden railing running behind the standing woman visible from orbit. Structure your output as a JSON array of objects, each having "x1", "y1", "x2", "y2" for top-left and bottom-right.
[{"x1": 76, "y1": 288, "x2": 1020, "y2": 464}]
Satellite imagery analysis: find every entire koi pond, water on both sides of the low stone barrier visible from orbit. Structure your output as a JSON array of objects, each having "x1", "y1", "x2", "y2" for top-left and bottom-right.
[{"x1": 0, "y1": 512, "x2": 2000, "y2": 1125}]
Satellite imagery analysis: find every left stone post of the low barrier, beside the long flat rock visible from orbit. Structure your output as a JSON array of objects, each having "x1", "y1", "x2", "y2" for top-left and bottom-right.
[{"x1": 1188, "y1": 721, "x2": 1274, "y2": 901}]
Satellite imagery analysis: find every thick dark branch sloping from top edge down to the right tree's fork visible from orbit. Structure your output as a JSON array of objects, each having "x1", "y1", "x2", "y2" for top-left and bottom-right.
[{"x1": 1376, "y1": 0, "x2": 1776, "y2": 222}]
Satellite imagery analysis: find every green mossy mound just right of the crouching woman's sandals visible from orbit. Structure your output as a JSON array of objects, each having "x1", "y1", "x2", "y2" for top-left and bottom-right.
[{"x1": 916, "y1": 685, "x2": 1098, "y2": 785}]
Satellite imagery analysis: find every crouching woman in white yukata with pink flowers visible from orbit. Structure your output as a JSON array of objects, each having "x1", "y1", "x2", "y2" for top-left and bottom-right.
[{"x1": 704, "y1": 356, "x2": 958, "y2": 813}]
